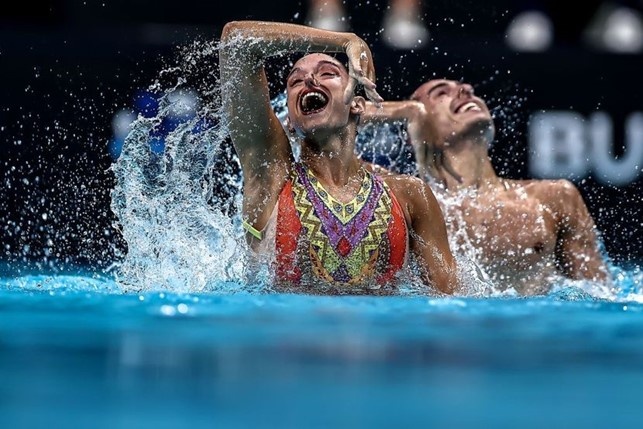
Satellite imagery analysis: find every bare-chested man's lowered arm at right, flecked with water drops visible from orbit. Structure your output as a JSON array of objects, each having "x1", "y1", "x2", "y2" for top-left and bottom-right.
[{"x1": 552, "y1": 180, "x2": 609, "y2": 281}]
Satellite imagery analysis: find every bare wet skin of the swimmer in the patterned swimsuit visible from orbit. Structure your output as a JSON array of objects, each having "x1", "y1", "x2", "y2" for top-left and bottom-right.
[{"x1": 220, "y1": 21, "x2": 457, "y2": 293}]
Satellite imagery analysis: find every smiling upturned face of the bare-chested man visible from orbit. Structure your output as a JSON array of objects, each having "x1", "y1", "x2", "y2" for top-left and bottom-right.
[{"x1": 411, "y1": 79, "x2": 493, "y2": 147}]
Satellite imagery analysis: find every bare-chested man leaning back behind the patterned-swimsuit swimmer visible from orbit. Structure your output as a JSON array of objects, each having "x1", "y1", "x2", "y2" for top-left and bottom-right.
[{"x1": 363, "y1": 79, "x2": 609, "y2": 295}]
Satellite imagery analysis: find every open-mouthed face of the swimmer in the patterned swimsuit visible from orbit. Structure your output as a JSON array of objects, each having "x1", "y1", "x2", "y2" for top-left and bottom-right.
[{"x1": 286, "y1": 54, "x2": 358, "y2": 135}]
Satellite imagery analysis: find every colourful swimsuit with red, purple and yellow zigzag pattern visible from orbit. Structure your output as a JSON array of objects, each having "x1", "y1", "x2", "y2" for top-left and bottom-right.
[{"x1": 275, "y1": 163, "x2": 408, "y2": 285}]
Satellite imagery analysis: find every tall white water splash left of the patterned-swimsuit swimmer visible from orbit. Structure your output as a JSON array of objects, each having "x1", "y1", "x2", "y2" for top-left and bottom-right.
[{"x1": 112, "y1": 42, "x2": 254, "y2": 292}]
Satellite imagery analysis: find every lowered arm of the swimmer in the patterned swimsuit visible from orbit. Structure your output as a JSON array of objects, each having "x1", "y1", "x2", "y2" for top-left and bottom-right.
[{"x1": 387, "y1": 176, "x2": 460, "y2": 294}]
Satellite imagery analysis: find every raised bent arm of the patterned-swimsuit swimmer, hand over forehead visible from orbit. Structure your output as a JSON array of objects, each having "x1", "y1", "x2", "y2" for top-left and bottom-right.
[{"x1": 219, "y1": 21, "x2": 379, "y2": 229}]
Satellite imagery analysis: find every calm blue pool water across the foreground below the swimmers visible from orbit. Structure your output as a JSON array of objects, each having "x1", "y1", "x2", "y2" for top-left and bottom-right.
[{"x1": 0, "y1": 275, "x2": 643, "y2": 428}]
